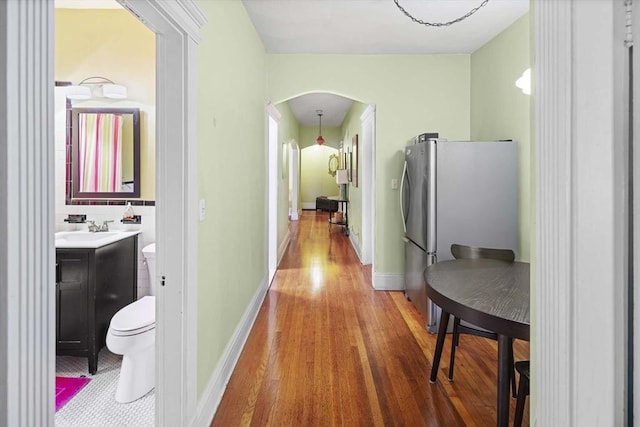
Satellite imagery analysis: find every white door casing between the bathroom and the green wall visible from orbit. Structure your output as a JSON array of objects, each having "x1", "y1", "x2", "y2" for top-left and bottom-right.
[{"x1": 118, "y1": 0, "x2": 206, "y2": 426}]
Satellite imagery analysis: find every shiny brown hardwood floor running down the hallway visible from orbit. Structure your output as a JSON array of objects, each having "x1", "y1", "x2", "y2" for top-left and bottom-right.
[{"x1": 211, "y1": 211, "x2": 529, "y2": 426}]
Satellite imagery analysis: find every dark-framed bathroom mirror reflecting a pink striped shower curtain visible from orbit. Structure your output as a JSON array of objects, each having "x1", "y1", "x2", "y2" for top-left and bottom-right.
[{"x1": 69, "y1": 108, "x2": 140, "y2": 199}]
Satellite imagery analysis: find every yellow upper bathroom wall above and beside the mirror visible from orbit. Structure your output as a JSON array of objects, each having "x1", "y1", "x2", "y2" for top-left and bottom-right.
[{"x1": 55, "y1": 9, "x2": 156, "y2": 200}]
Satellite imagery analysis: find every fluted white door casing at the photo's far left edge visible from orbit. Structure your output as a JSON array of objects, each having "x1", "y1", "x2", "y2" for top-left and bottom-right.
[{"x1": 0, "y1": 0, "x2": 56, "y2": 426}]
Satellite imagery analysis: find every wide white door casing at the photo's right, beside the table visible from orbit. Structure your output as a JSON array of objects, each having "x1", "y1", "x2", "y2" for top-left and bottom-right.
[{"x1": 531, "y1": 0, "x2": 625, "y2": 426}]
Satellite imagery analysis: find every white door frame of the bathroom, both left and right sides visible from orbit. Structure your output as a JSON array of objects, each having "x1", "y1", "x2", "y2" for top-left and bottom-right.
[{"x1": 0, "y1": 0, "x2": 206, "y2": 426}]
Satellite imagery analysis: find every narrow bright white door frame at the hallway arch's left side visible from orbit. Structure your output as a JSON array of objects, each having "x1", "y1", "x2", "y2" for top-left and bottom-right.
[{"x1": 265, "y1": 103, "x2": 282, "y2": 284}]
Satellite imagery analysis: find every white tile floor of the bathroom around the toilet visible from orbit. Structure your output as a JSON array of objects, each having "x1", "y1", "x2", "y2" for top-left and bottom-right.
[{"x1": 55, "y1": 348, "x2": 155, "y2": 427}]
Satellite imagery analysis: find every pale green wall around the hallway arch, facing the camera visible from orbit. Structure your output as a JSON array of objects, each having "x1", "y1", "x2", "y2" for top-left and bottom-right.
[{"x1": 267, "y1": 54, "x2": 470, "y2": 273}]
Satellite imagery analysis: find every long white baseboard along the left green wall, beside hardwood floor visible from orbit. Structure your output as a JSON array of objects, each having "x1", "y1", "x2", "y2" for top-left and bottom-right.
[{"x1": 191, "y1": 279, "x2": 269, "y2": 427}]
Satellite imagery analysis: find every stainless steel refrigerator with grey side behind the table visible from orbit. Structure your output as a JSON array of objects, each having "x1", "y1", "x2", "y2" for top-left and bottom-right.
[{"x1": 400, "y1": 134, "x2": 518, "y2": 333}]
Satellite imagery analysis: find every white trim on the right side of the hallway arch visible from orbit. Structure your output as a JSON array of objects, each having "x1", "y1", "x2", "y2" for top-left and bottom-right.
[{"x1": 360, "y1": 104, "x2": 376, "y2": 270}]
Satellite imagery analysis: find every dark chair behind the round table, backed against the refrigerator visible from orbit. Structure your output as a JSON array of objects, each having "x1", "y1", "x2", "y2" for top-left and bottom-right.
[{"x1": 449, "y1": 243, "x2": 516, "y2": 397}]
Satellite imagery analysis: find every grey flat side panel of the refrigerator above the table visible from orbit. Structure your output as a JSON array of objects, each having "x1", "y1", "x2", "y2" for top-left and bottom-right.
[{"x1": 437, "y1": 142, "x2": 518, "y2": 261}]
